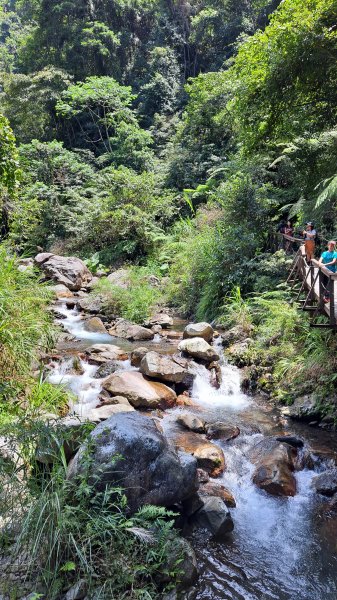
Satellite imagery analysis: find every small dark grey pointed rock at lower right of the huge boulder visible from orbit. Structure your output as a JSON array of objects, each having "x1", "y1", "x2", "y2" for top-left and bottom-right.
[{"x1": 193, "y1": 496, "x2": 234, "y2": 539}]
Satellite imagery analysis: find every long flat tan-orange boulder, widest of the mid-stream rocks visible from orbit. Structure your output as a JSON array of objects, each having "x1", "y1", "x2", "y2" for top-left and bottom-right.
[{"x1": 103, "y1": 371, "x2": 177, "y2": 408}]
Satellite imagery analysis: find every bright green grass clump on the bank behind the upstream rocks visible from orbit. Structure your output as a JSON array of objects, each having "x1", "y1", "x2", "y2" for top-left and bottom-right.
[{"x1": 94, "y1": 267, "x2": 163, "y2": 323}]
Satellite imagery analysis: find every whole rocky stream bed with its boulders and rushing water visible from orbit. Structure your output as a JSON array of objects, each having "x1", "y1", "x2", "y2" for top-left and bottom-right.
[{"x1": 30, "y1": 253, "x2": 337, "y2": 600}]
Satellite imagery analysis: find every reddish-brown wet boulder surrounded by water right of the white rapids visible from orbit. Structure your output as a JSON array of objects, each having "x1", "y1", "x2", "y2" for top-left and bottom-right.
[{"x1": 250, "y1": 438, "x2": 297, "y2": 496}]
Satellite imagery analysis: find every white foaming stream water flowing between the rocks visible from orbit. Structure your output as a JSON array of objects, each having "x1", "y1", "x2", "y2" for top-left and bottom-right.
[{"x1": 48, "y1": 302, "x2": 337, "y2": 600}]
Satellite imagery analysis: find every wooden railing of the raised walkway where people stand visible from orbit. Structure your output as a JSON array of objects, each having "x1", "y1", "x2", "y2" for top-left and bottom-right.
[{"x1": 280, "y1": 234, "x2": 337, "y2": 330}]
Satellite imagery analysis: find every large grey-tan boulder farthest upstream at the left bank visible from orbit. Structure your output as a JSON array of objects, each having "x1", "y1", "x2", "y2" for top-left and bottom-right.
[{"x1": 34, "y1": 253, "x2": 92, "y2": 291}]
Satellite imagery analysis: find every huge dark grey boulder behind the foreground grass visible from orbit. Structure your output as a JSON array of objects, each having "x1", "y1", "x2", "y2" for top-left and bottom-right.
[{"x1": 68, "y1": 411, "x2": 198, "y2": 512}]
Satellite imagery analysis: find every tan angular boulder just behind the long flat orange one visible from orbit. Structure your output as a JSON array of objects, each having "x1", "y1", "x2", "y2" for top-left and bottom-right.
[{"x1": 139, "y1": 352, "x2": 189, "y2": 383}]
